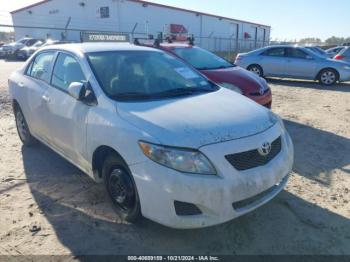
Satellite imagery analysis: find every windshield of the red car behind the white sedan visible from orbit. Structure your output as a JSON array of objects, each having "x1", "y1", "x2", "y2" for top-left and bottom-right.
[{"x1": 173, "y1": 47, "x2": 234, "y2": 70}]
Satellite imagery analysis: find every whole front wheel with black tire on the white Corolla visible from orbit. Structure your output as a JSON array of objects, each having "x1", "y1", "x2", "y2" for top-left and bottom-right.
[{"x1": 102, "y1": 154, "x2": 142, "y2": 223}]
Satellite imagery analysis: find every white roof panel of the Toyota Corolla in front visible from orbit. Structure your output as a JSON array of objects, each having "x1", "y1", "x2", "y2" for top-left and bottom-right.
[{"x1": 41, "y1": 42, "x2": 161, "y2": 54}]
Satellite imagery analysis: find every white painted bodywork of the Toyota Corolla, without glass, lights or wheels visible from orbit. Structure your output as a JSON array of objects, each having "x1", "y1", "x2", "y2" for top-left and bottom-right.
[{"x1": 9, "y1": 43, "x2": 294, "y2": 228}]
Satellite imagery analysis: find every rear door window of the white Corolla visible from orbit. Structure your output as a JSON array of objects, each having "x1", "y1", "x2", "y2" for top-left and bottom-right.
[{"x1": 27, "y1": 52, "x2": 55, "y2": 83}]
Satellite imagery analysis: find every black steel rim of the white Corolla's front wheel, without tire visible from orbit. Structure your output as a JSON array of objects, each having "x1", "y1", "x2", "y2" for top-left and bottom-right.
[{"x1": 108, "y1": 168, "x2": 136, "y2": 212}]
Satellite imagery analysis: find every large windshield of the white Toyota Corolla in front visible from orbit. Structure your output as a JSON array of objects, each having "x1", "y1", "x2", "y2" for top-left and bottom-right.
[{"x1": 87, "y1": 51, "x2": 218, "y2": 101}]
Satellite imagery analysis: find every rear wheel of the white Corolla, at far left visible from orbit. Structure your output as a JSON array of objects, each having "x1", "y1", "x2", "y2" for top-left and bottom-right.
[{"x1": 14, "y1": 105, "x2": 38, "y2": 147}]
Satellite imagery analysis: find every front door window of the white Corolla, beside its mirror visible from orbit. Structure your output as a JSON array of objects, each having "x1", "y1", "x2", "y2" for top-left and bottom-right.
[{"x1": 51, "y1": 53, "x2": 86, "y2": 90}]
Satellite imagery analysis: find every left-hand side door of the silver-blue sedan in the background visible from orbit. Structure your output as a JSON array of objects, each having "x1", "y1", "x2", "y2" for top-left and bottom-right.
[{"x1": 259, "y1": 47, "x2": 286, "y2": 76}]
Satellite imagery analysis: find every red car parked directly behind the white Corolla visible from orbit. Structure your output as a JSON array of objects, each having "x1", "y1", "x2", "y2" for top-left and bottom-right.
[{"x1": 150, "y1": 43, "x2": 272, "y2": 108}]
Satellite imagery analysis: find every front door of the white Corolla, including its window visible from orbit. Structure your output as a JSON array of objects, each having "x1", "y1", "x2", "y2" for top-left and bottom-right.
[{"x1": 45, "y1": 52, "x2": 90, "y2": 165}]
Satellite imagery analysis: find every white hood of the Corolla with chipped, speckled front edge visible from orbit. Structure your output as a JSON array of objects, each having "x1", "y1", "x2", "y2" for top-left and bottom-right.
[{"x1": 117, "y1": 88, "x2": 274, "y2": 148}]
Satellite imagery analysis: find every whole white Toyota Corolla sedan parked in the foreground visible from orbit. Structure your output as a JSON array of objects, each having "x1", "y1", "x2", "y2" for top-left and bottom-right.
[{"x1": 9, "y1": 43, "x2": 293, "y2": 228}]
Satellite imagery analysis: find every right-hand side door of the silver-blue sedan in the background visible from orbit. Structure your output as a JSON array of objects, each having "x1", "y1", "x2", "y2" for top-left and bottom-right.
[{"x1": 286, "y1": 47, "x2": 317, "y2": 79}]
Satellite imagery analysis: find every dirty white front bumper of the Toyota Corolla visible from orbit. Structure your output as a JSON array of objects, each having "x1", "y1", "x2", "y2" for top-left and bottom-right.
[{"x1": 130, "y1": 124, "x2": 293, "y2": 228}]
